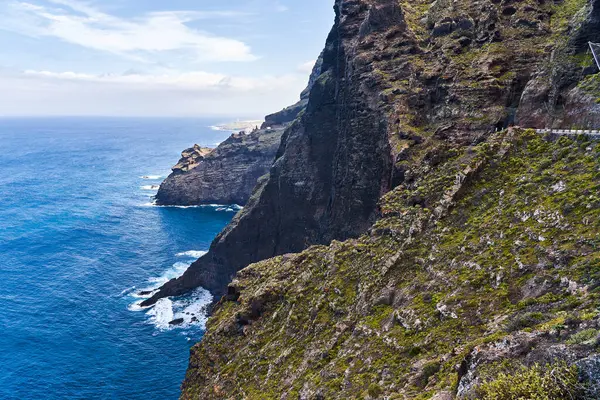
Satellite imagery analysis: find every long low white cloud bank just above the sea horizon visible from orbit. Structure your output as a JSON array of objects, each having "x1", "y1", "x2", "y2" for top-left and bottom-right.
[{"x1": 0, "y1": 70, "x2": 306, "y2": 117}]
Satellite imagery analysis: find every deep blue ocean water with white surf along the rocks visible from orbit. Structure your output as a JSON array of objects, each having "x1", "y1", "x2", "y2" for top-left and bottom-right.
[{"x1": 0, "y1": 118, "x2": 239, "y2": 399}]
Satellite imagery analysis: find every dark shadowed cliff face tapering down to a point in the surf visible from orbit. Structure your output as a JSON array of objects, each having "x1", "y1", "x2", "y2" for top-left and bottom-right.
[{"x1": 144, "y1": 0, "x2": 393, "y2": 305}]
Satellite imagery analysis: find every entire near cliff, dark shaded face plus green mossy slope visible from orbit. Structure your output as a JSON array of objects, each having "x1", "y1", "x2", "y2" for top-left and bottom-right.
[{"x1": 155, "y1": 0, "x2": 600, "y2": 400}]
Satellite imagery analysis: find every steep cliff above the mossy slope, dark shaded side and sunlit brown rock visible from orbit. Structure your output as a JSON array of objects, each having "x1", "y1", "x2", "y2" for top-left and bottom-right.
[{"x1": 146, "y1": 0, "x2": 596, "y2": 304}]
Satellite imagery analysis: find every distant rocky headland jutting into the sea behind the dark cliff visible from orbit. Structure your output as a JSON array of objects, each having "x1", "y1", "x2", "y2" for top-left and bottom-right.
[{"x1": 156, "y1": 127, "x2": 284, "y2": 206}]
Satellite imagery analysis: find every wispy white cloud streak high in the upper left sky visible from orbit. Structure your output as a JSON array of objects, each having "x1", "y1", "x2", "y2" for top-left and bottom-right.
[{"x1": 0, "y1": 0, "x2": 257, "y2": 62}]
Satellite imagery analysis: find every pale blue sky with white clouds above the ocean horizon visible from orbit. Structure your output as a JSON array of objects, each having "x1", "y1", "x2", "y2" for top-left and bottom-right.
[{"x1": 0, "y1": 0, "x2": 334, "y2": 118}]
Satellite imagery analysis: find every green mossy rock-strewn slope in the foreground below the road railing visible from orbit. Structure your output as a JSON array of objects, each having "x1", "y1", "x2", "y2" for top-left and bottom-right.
[{"x1": 182, "y1": 129, "x2": 600, "y2": 400}]
